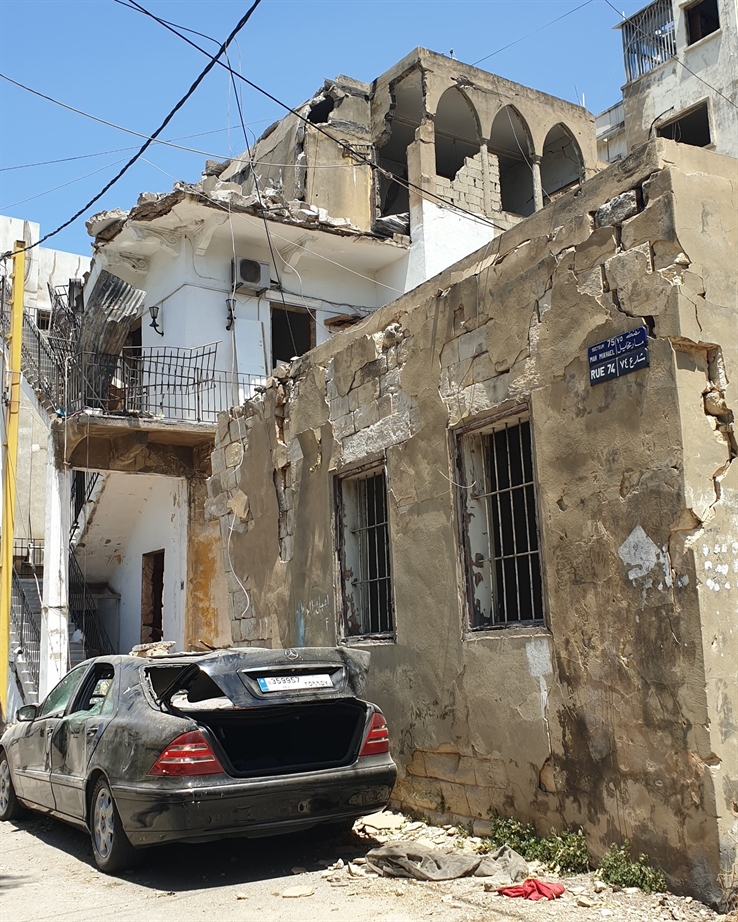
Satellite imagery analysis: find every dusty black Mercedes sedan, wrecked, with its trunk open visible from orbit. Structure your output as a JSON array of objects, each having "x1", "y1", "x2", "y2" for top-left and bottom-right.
[{"x1": 0, "y1": 647, "x2": 396, "y2": 873}]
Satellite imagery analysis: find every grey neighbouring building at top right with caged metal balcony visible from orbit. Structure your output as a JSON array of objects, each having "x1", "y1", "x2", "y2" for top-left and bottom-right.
[{"x1": 596, "y1": 0, "x2": 738, "y2": 162}]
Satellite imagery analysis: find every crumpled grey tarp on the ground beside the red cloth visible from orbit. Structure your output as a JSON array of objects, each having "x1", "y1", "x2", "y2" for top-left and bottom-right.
[{"x1": 366, "y1": 842, "x2": 528, "y2": 887}]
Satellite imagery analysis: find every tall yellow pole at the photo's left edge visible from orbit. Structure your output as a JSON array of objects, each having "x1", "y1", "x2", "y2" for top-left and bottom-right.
[{"x1": 0, "y1": 240, "x2": 26, "y2": 721}]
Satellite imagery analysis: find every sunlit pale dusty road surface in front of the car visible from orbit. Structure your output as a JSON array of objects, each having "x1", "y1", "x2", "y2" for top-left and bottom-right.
[{"x1": 0, "y1": 814, "x2": 738, "y2": 922}]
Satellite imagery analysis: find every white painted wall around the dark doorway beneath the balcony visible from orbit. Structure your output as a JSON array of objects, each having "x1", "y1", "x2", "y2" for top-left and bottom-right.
[{"x1": 77, "y1": 473, "x2": 187, "y2": 653}]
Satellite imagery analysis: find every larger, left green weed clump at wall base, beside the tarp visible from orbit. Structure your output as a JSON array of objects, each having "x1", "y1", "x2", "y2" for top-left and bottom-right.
[{"x1": 478, "y1": 811, "x2": 590, "y2": 874}]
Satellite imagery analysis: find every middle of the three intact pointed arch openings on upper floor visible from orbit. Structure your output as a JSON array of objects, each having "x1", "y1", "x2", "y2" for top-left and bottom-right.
[{"x1": 489, "y1": 106, "x2": 535, "y2": 217}]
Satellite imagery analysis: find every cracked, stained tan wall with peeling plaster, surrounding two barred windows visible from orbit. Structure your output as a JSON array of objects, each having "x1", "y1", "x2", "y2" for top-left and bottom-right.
[{"x1": 209, "y1": 141, "x2": 738, "y2": 901}]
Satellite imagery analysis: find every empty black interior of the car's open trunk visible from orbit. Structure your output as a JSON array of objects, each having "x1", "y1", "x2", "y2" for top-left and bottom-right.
[{"x1": 192, "y1": 700, "x2": 366, "y2": 777}]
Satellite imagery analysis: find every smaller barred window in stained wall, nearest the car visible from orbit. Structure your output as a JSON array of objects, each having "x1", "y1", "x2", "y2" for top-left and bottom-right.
[{"x1": 336, "y1": 468, "x2": 395, "y2": 638}]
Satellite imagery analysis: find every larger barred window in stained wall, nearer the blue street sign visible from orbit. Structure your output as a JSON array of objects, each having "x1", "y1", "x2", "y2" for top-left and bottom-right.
[{"x1": 458, "y1": 412, "x2": 543, "y2": 631}]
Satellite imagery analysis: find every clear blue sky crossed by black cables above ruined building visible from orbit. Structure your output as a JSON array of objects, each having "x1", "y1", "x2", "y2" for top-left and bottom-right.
[{"x1": 0, "y1": 0, "x2": 643, "y2": 253}]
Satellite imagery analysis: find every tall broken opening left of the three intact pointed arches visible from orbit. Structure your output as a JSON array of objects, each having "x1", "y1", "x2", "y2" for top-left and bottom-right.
[{"x1": 377, "y1": 70, "x2": 425, "y2": 217}]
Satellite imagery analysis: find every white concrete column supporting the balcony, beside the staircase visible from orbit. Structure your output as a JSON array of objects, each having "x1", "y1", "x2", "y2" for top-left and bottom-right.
[{"x1": 38, "y1": 431, "x2": 72, "y2": 701}]
